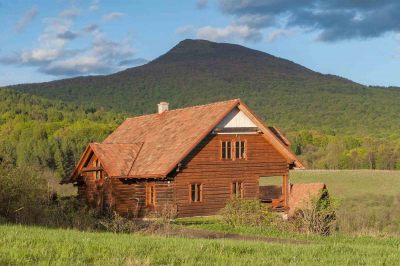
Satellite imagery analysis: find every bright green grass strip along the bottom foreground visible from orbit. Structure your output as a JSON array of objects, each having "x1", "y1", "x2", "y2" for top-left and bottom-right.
[{"x1": 0, "y1": 225, "x2": 400, "y2": 265}]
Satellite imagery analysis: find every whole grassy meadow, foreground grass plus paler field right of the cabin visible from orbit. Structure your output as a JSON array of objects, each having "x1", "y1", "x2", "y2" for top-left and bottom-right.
[{"x1": 0, "y1": 170, "x2": 400, "y2": 265}]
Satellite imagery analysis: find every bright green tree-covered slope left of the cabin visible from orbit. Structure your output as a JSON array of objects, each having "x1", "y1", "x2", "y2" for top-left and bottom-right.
[{"x1": 0, "y1": 90, "x2": 126, "y2": 177}]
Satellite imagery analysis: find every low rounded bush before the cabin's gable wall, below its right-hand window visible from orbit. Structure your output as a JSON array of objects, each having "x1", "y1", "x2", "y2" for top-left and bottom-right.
[{"x1": 221, "y1": 199, "x2": 275, "y2": 227}]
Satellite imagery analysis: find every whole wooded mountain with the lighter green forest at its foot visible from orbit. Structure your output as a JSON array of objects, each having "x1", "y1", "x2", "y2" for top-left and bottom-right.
[{"x1": 0, "y1": 40, "x2": 400, "y2": 169}]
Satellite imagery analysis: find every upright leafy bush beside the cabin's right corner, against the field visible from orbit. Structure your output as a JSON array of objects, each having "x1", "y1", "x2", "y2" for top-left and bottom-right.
[{"x1": 292, "y1": 189, "x2": 339, "y2": 235}]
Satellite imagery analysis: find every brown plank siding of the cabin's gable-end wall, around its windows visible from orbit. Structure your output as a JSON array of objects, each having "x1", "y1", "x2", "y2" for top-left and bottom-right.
[{"x1": 174, "y1": 134, "x2": 288, "y2": 217}]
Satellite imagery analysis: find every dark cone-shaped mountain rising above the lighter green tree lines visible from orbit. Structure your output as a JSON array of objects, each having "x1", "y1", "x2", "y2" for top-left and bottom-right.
[{"x1": 6, "y1": 40, "x2": 400, "y2": 136}]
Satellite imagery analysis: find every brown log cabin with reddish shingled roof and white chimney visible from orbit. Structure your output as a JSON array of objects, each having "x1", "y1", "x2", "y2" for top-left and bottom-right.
[{"x1": 62, "y1": 99, "x2": 304, "y2": 217}]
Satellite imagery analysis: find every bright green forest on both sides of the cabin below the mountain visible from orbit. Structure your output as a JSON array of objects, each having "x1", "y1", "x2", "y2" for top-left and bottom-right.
[{"x1": 0, "y1": 89, "x2": 400, "y2": 181}]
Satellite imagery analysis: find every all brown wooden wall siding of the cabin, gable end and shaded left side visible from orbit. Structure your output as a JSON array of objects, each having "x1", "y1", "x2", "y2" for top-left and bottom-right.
[{"x1": 78, "y1": 134, "x2": 288, "y2": 217}]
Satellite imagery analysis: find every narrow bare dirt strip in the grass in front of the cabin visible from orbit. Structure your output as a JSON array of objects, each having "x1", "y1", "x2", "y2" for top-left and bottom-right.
[{"x1": 168, "y1": 228, "x2": 310, "y2": 244}]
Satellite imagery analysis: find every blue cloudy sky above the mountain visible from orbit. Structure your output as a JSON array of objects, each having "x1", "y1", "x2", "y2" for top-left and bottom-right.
[{"x1": 0, "y1": 0, "x2": 400, "y2": 86}]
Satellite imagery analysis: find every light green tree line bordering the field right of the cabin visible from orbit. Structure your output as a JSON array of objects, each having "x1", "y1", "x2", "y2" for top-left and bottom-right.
[{"x1": 291, "y1": 131, "x2": 400, "y2": 170}]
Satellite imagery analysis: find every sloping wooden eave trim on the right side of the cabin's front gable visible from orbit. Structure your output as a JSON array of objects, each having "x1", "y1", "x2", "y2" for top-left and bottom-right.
[{"x1": 238, "y1": 102, "x2": 305, "y2": 169}]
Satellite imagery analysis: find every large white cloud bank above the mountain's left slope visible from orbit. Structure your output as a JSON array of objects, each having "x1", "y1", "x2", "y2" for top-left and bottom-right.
[{"x1": 0, "y1": 8, "x2": 147, "y2": 77}]
